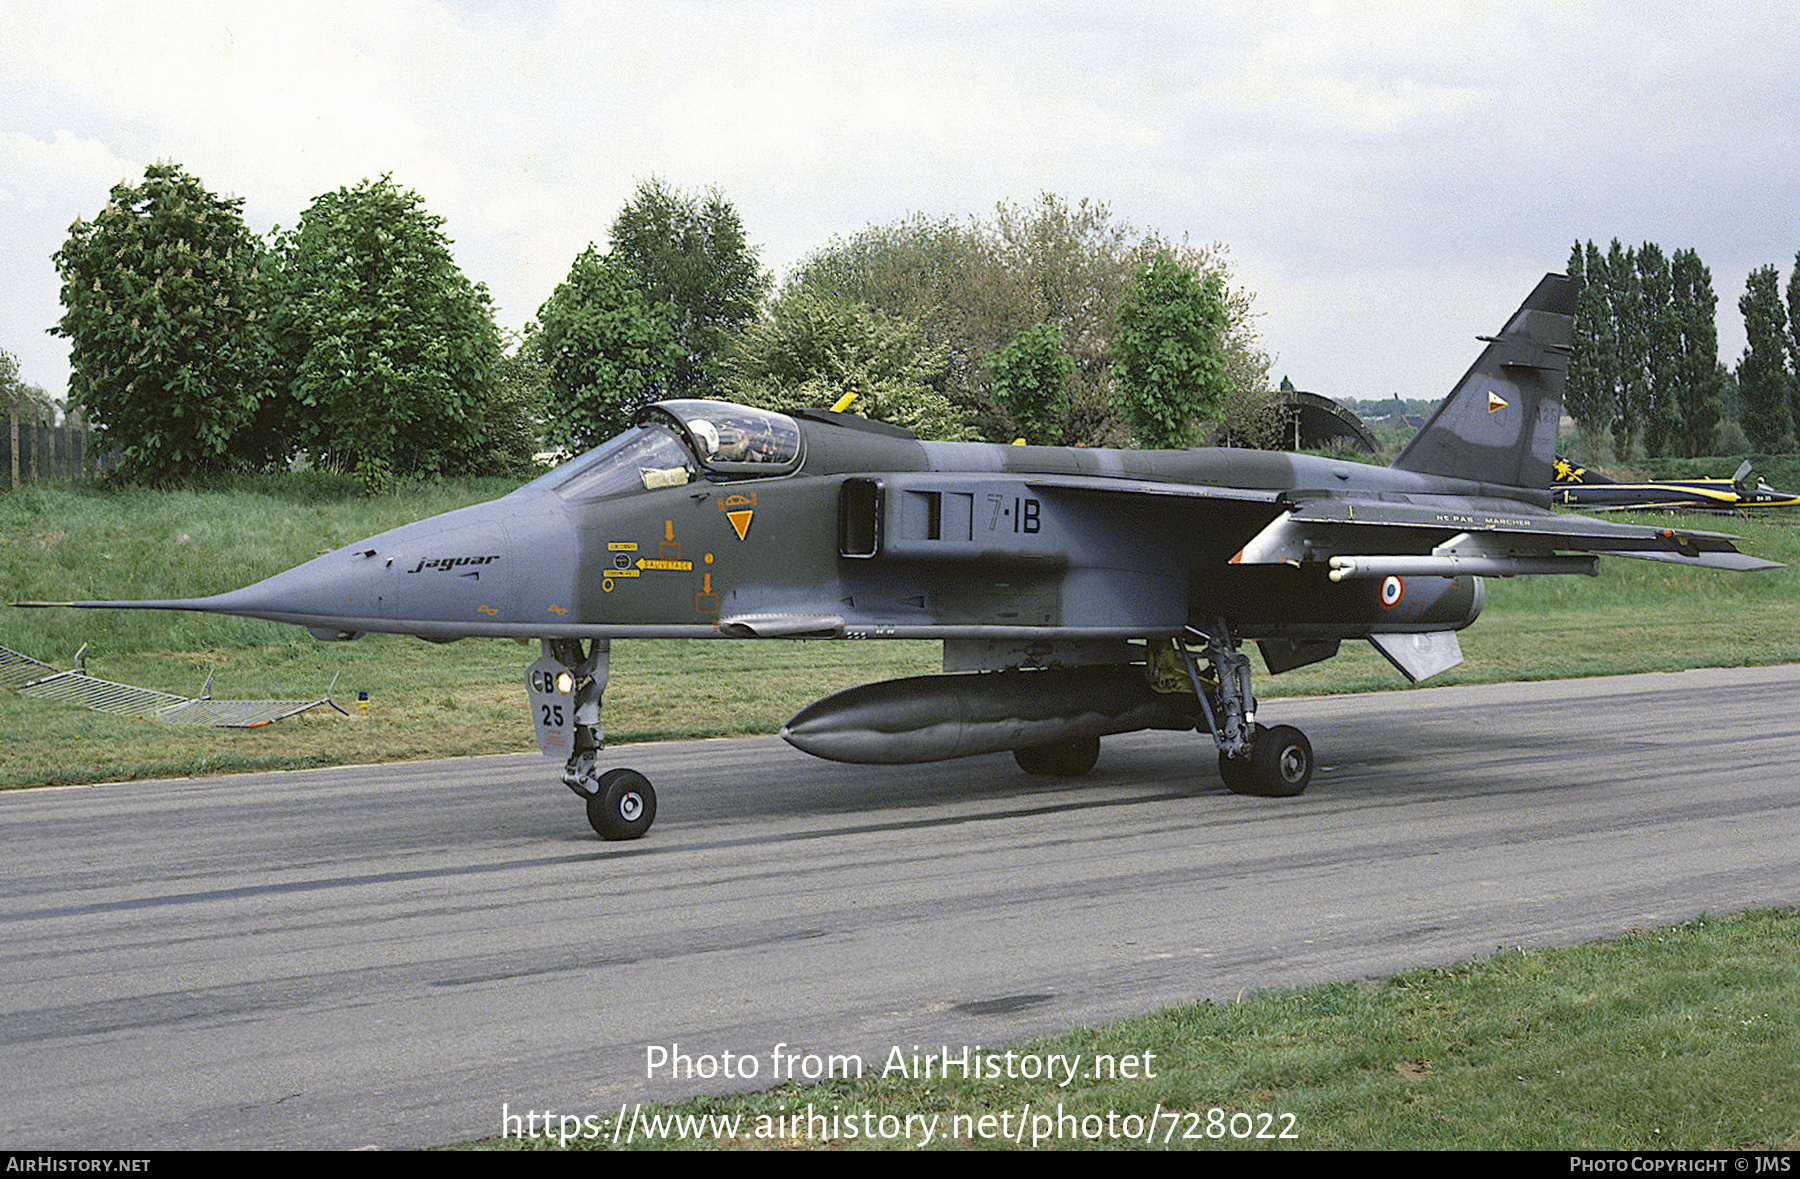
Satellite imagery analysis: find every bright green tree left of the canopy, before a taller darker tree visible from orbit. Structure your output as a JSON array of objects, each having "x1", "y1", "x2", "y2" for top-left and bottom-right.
[{"x1": 529, "y1": 245, "x2": 686, "y2": 448}]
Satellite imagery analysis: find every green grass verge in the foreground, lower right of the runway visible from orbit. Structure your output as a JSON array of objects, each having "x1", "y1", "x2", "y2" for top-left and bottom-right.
[{"x1": 470, "y1": 911, "x2": 1800, "y2": 1170}]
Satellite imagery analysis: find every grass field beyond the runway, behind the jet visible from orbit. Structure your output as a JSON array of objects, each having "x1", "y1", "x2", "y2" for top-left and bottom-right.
[{"x1": 0, "y1": 475, "x2": 1800, "y2": 788}]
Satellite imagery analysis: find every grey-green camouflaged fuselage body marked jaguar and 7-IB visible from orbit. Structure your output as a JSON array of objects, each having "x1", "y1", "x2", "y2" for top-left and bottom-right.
[{"x1": 154, "y1": 403, "x2": 1497, "y2": 639}]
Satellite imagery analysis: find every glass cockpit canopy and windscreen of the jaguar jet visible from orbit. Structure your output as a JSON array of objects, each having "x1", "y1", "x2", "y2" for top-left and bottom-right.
[{"x1": 529, "y1": 400, "x2": 801, "y2": 502}]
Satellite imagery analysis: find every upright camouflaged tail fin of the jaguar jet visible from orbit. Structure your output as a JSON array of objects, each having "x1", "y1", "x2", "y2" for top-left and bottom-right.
[{"x1": 1393, "y1": 274, "x2": 1577, "y2": 495}]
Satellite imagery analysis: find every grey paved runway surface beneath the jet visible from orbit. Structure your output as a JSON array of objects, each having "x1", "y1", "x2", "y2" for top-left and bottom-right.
[{"x1": 0, "y1": 668, "x2": 1800, "y2": 1150}]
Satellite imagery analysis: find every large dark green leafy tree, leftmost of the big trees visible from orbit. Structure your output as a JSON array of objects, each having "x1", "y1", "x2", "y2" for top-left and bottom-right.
[{"x1": 52, "y1": 164, "x2": 270, "y2": 482}]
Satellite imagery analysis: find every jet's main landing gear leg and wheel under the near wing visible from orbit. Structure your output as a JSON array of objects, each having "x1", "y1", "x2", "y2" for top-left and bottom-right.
[{"x1": 1175, "y1": 619, "x2": 1312, "y2": 797}]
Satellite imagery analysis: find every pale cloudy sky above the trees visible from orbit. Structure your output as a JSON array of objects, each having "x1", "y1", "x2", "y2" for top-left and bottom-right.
[{"x1": 0, "y1": 0, "x2": 1800, "y2": 415}]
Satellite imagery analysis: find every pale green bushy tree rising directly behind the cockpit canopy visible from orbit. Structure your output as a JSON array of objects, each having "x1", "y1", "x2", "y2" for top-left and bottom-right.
[{"x1": 733, "y1": 286, "x2": 967, "y2": 441}]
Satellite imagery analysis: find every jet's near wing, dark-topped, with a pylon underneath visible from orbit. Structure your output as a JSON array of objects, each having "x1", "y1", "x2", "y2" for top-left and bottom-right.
[{"x1": 1233, "y1": 495, "x2": 1780, "y2": 580}]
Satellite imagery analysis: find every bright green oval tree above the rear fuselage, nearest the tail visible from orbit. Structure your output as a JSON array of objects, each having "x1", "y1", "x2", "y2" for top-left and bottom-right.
[{"x1": 1116, "y1": 254, "x2": 1229, "y2": 446}]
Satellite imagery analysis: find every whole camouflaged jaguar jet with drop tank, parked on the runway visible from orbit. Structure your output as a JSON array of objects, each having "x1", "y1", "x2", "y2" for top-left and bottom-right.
[{"x1": 21, "y1": 275, "x2": 1771, "y2": 839}]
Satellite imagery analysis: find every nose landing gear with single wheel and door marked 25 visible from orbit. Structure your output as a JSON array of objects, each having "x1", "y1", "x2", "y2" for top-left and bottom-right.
[{"x1": 529, "y1": 639, "x2": 657, "y2": 839}]
